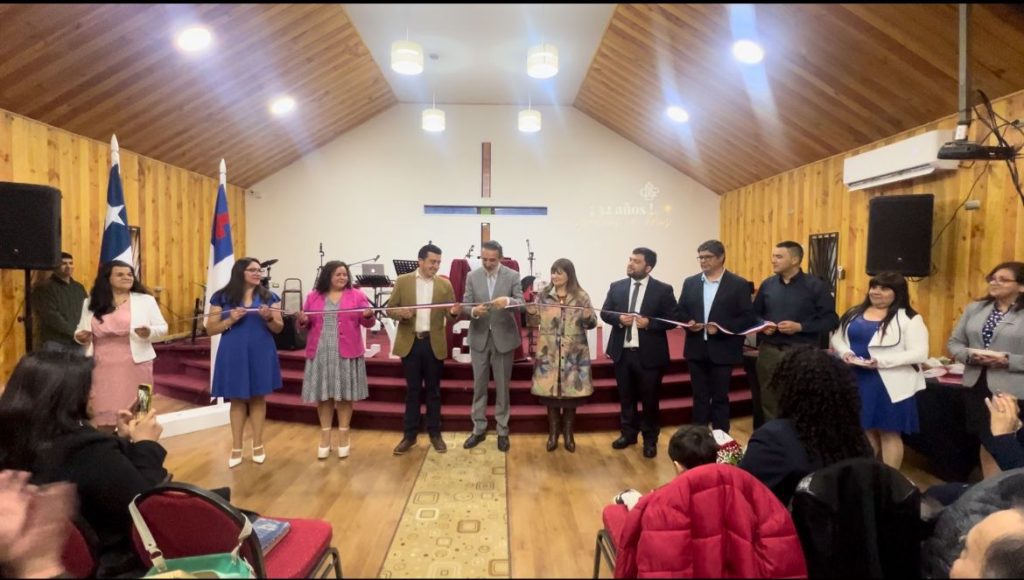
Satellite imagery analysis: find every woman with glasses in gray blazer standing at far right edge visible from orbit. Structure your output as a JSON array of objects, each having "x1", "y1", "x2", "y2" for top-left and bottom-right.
[{"x1": 946, "y1": 261, "x2": 1024, "y2": 478}]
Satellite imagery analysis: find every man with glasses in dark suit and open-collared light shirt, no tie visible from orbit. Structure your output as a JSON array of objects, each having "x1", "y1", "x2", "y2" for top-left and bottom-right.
[{"x1": 676, "y1": 240, "x2": 757, "y2": 431}]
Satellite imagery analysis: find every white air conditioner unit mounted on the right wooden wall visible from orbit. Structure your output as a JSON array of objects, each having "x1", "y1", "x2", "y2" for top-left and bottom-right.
[{"x1": 843, "y1": 129, "x2": 959, "y2": 192}]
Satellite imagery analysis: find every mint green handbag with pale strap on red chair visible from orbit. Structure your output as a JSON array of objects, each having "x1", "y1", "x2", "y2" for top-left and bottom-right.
[{"x1": 128, "y1": 496, "x2": 256, "y2": 578}]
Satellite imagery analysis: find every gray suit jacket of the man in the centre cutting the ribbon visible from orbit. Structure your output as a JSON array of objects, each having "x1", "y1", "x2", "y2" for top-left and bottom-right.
[{"x1": 462, "y1": 264, "x2": 522, "y2": 353}]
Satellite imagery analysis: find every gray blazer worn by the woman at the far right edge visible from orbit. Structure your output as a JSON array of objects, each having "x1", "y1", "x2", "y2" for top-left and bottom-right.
[{"x1": 946, "y1": 301, "x2": 1024, "y2": 399}]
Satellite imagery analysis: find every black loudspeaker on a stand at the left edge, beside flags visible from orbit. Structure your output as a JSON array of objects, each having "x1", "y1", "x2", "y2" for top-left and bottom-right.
[{"x1": 0, "y1": 181, "x2": 60, "y2": 270}]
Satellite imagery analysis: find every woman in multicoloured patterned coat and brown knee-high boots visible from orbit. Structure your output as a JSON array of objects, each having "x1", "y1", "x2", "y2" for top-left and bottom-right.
[{"x1": 526, "y1": 258, "x2": 598, "y2": 452}]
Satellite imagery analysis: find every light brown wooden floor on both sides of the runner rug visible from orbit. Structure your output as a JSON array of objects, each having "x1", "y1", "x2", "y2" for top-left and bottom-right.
[{"x1": 158, "y1": 402, "x2": 939, "y2": 578}]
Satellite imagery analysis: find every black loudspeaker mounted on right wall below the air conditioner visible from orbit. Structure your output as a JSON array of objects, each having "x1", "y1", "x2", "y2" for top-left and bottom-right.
[{"x1": 867, "y1": 194, "x2": 935, "y2": 277}]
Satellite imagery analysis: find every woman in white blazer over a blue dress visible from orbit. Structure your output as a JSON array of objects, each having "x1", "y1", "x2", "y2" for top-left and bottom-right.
[{"x1": 831, "y1": 272, "x2": 928, "y2": 469}]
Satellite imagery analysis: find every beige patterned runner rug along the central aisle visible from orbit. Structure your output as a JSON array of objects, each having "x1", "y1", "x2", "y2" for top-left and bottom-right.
[{"x1": 380, "y1": 431, "x2": 509, "y2": 578}]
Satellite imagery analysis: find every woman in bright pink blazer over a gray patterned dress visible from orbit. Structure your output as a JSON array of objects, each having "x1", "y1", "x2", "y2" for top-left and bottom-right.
[{"x1": 299, "y1": 260, "x2": 374, "y2": 459}]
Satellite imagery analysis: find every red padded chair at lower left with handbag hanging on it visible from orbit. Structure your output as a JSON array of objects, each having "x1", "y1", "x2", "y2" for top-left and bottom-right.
[{"x1": 132, "y1": 483, "x2": 342, "y2": 579}]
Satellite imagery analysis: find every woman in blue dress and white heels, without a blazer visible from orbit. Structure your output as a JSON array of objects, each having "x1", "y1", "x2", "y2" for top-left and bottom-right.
[{"x1": 206, "y1": 258, "x2": 285, "y2": 467}]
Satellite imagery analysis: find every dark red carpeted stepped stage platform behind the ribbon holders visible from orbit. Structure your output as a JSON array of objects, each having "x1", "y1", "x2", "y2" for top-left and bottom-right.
[{"x1": 154, "y1": 330, "x2": 751, "y2": 432}]
